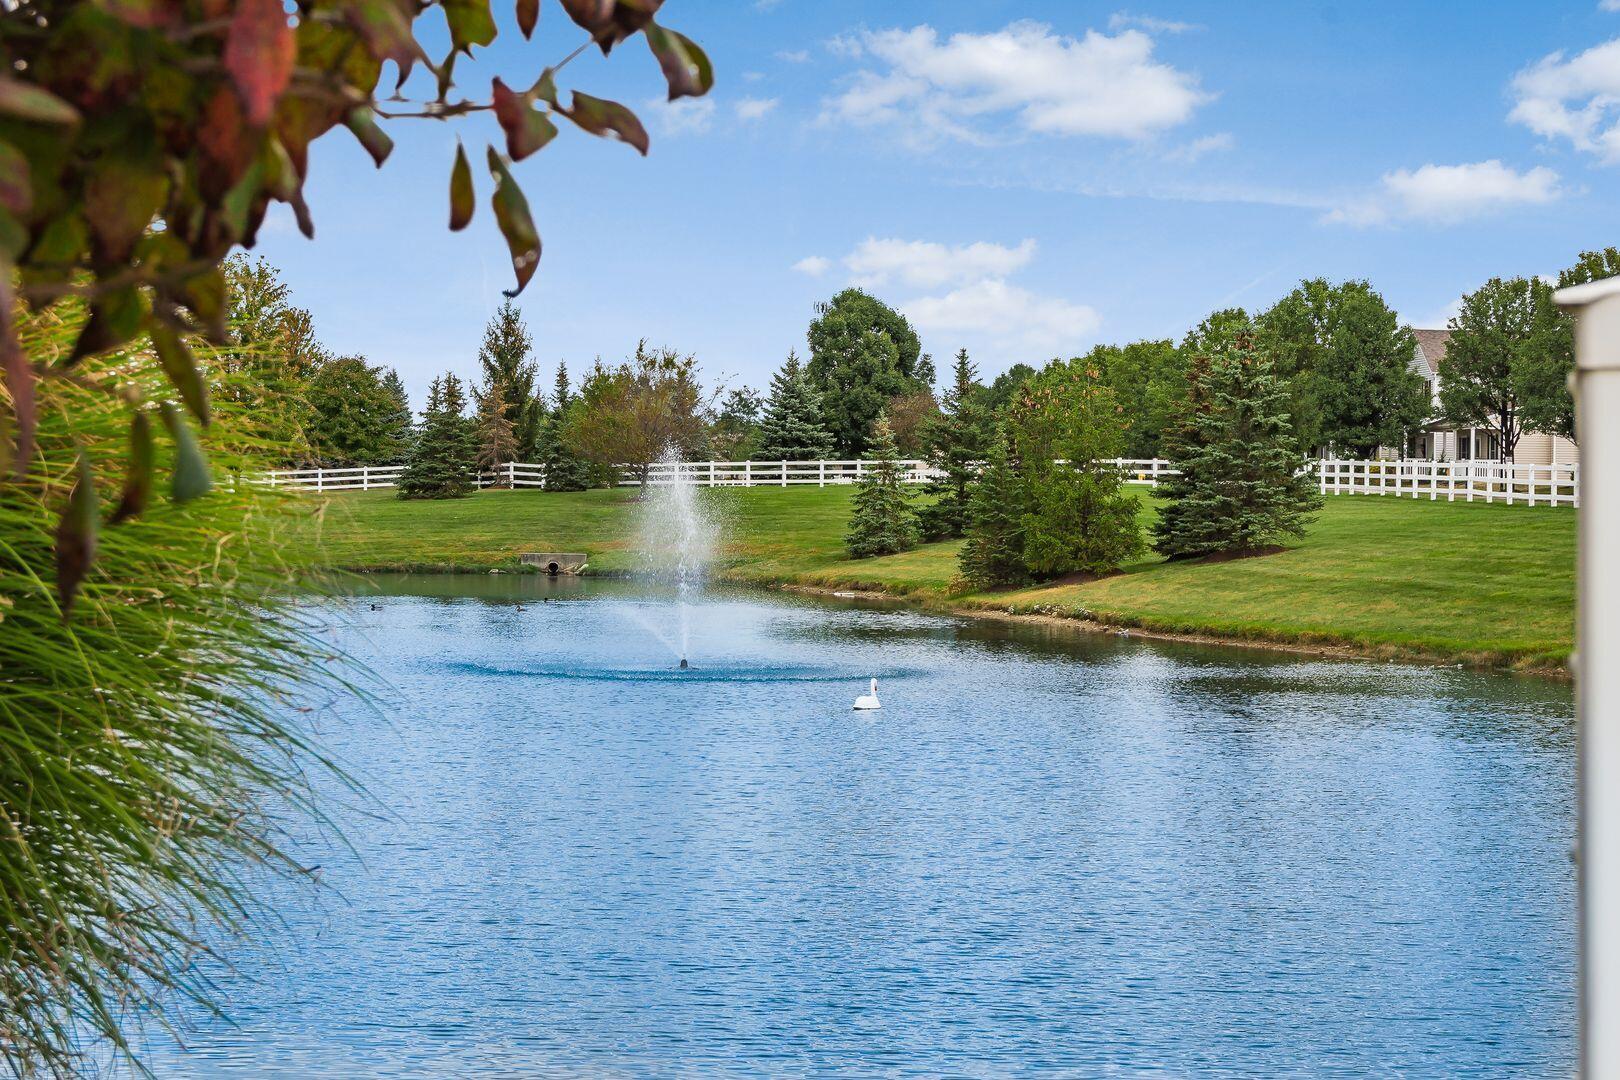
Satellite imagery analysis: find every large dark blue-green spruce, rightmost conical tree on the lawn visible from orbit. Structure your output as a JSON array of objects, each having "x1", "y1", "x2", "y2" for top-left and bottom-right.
[{"x1": 1153, "y1": 335, "x2": 1322, "y2": 557}]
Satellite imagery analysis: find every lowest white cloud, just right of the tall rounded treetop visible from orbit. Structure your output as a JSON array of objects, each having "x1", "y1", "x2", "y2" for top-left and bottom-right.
[{"x1": 901, "y1": 279, "x2": 1102, "y2": 355}]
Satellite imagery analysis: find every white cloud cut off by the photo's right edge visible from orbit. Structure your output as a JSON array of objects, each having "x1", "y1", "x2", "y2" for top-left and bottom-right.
[{"x1": 1508, "y1": 36, "x2": 1620, "y2": 164}]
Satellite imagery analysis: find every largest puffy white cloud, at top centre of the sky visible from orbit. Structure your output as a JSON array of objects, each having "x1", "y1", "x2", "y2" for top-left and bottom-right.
[{"x1": 821, "y1": 21, "x2": 1212, "y2": 144}]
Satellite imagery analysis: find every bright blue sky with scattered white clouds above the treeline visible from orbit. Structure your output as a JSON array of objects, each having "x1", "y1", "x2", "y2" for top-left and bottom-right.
[{"x1": 258, "y1": 0, "x2": 1620, "y2": 405}]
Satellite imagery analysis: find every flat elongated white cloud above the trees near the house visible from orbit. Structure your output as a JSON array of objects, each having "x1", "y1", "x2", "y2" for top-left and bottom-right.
[{"x1": 1327, "y1": 159, "x2": 1562, "y2": 225}]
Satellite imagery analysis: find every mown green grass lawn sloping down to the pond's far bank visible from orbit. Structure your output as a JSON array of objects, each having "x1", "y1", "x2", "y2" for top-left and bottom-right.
[{"x1": 311, "y1": 487, "x2": 1575, "y2": 667}]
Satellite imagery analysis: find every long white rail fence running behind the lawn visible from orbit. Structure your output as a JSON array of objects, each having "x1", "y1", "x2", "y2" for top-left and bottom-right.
[{"x1": 264, "y1": 458, "x2": 1580, "y2": 507}]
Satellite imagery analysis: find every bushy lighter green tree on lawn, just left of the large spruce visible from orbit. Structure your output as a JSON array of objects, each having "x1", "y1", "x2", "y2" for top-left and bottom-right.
[{"x1": 1008, "y1": 359, "x2": 1145, "y2": 578}]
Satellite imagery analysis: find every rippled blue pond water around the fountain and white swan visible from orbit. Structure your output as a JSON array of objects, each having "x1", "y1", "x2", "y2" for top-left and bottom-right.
[{"x1": 136, "y1": 578, "x2": 1575, "y2": 1077}]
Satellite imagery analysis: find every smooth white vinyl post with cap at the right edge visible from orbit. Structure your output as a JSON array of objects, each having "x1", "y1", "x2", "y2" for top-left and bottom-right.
[{"x1": 1554, "y1": 277, "x2": 1620, "y2": 1077}]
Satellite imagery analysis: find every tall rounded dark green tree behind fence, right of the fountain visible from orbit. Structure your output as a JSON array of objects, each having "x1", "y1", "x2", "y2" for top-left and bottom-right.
[{"x1": 805, "y1": 288, "x2": 933, "y2": 458}]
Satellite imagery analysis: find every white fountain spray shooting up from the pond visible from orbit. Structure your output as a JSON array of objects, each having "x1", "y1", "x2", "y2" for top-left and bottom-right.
[{"x1": 630, "y1": 453, "x2": 718, "y2": 670}]
